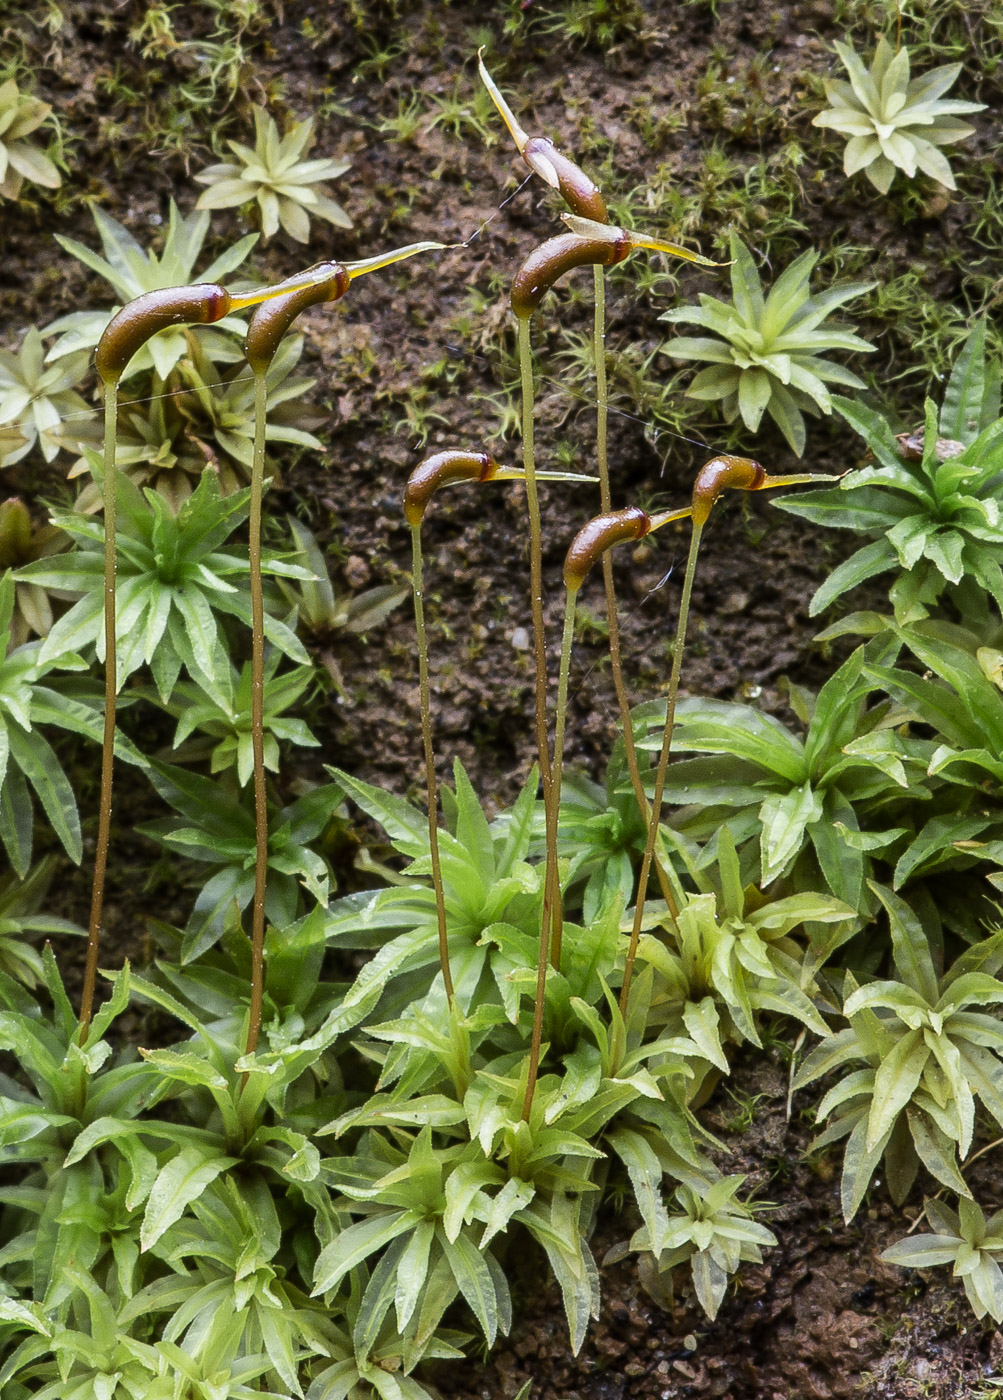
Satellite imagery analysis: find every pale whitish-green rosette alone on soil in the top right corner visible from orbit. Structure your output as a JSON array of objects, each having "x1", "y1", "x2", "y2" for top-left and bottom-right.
[{"x1": 812, "y1": 36, "x2": 985, "y2": 195}]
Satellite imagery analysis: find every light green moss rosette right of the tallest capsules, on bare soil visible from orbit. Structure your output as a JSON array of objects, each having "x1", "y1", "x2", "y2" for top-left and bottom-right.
[{"x1": 661, "y1": 234, "x2": 874, "y2": 456}]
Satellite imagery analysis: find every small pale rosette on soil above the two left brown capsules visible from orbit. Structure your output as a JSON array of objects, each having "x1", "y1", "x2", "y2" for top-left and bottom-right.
[{"x1": 195, "y1": 108, "x2": 352, "y2": 244}]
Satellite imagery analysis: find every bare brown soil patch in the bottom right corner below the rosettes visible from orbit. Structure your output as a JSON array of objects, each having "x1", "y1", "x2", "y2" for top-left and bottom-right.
[{"x1": 437, "y1": 1054, "x2": 1003, "y2": 1400}]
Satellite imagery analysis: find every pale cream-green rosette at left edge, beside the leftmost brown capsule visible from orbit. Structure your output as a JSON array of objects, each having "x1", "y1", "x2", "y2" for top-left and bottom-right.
[{"x1": 0, "y1": 327, "x2": 94, "y2": 466}]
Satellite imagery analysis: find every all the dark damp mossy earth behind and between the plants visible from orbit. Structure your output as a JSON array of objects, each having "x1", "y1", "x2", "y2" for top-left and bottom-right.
[{"x1": 0, "y1": 0, "x2": 1003, "y2": 1400}]
